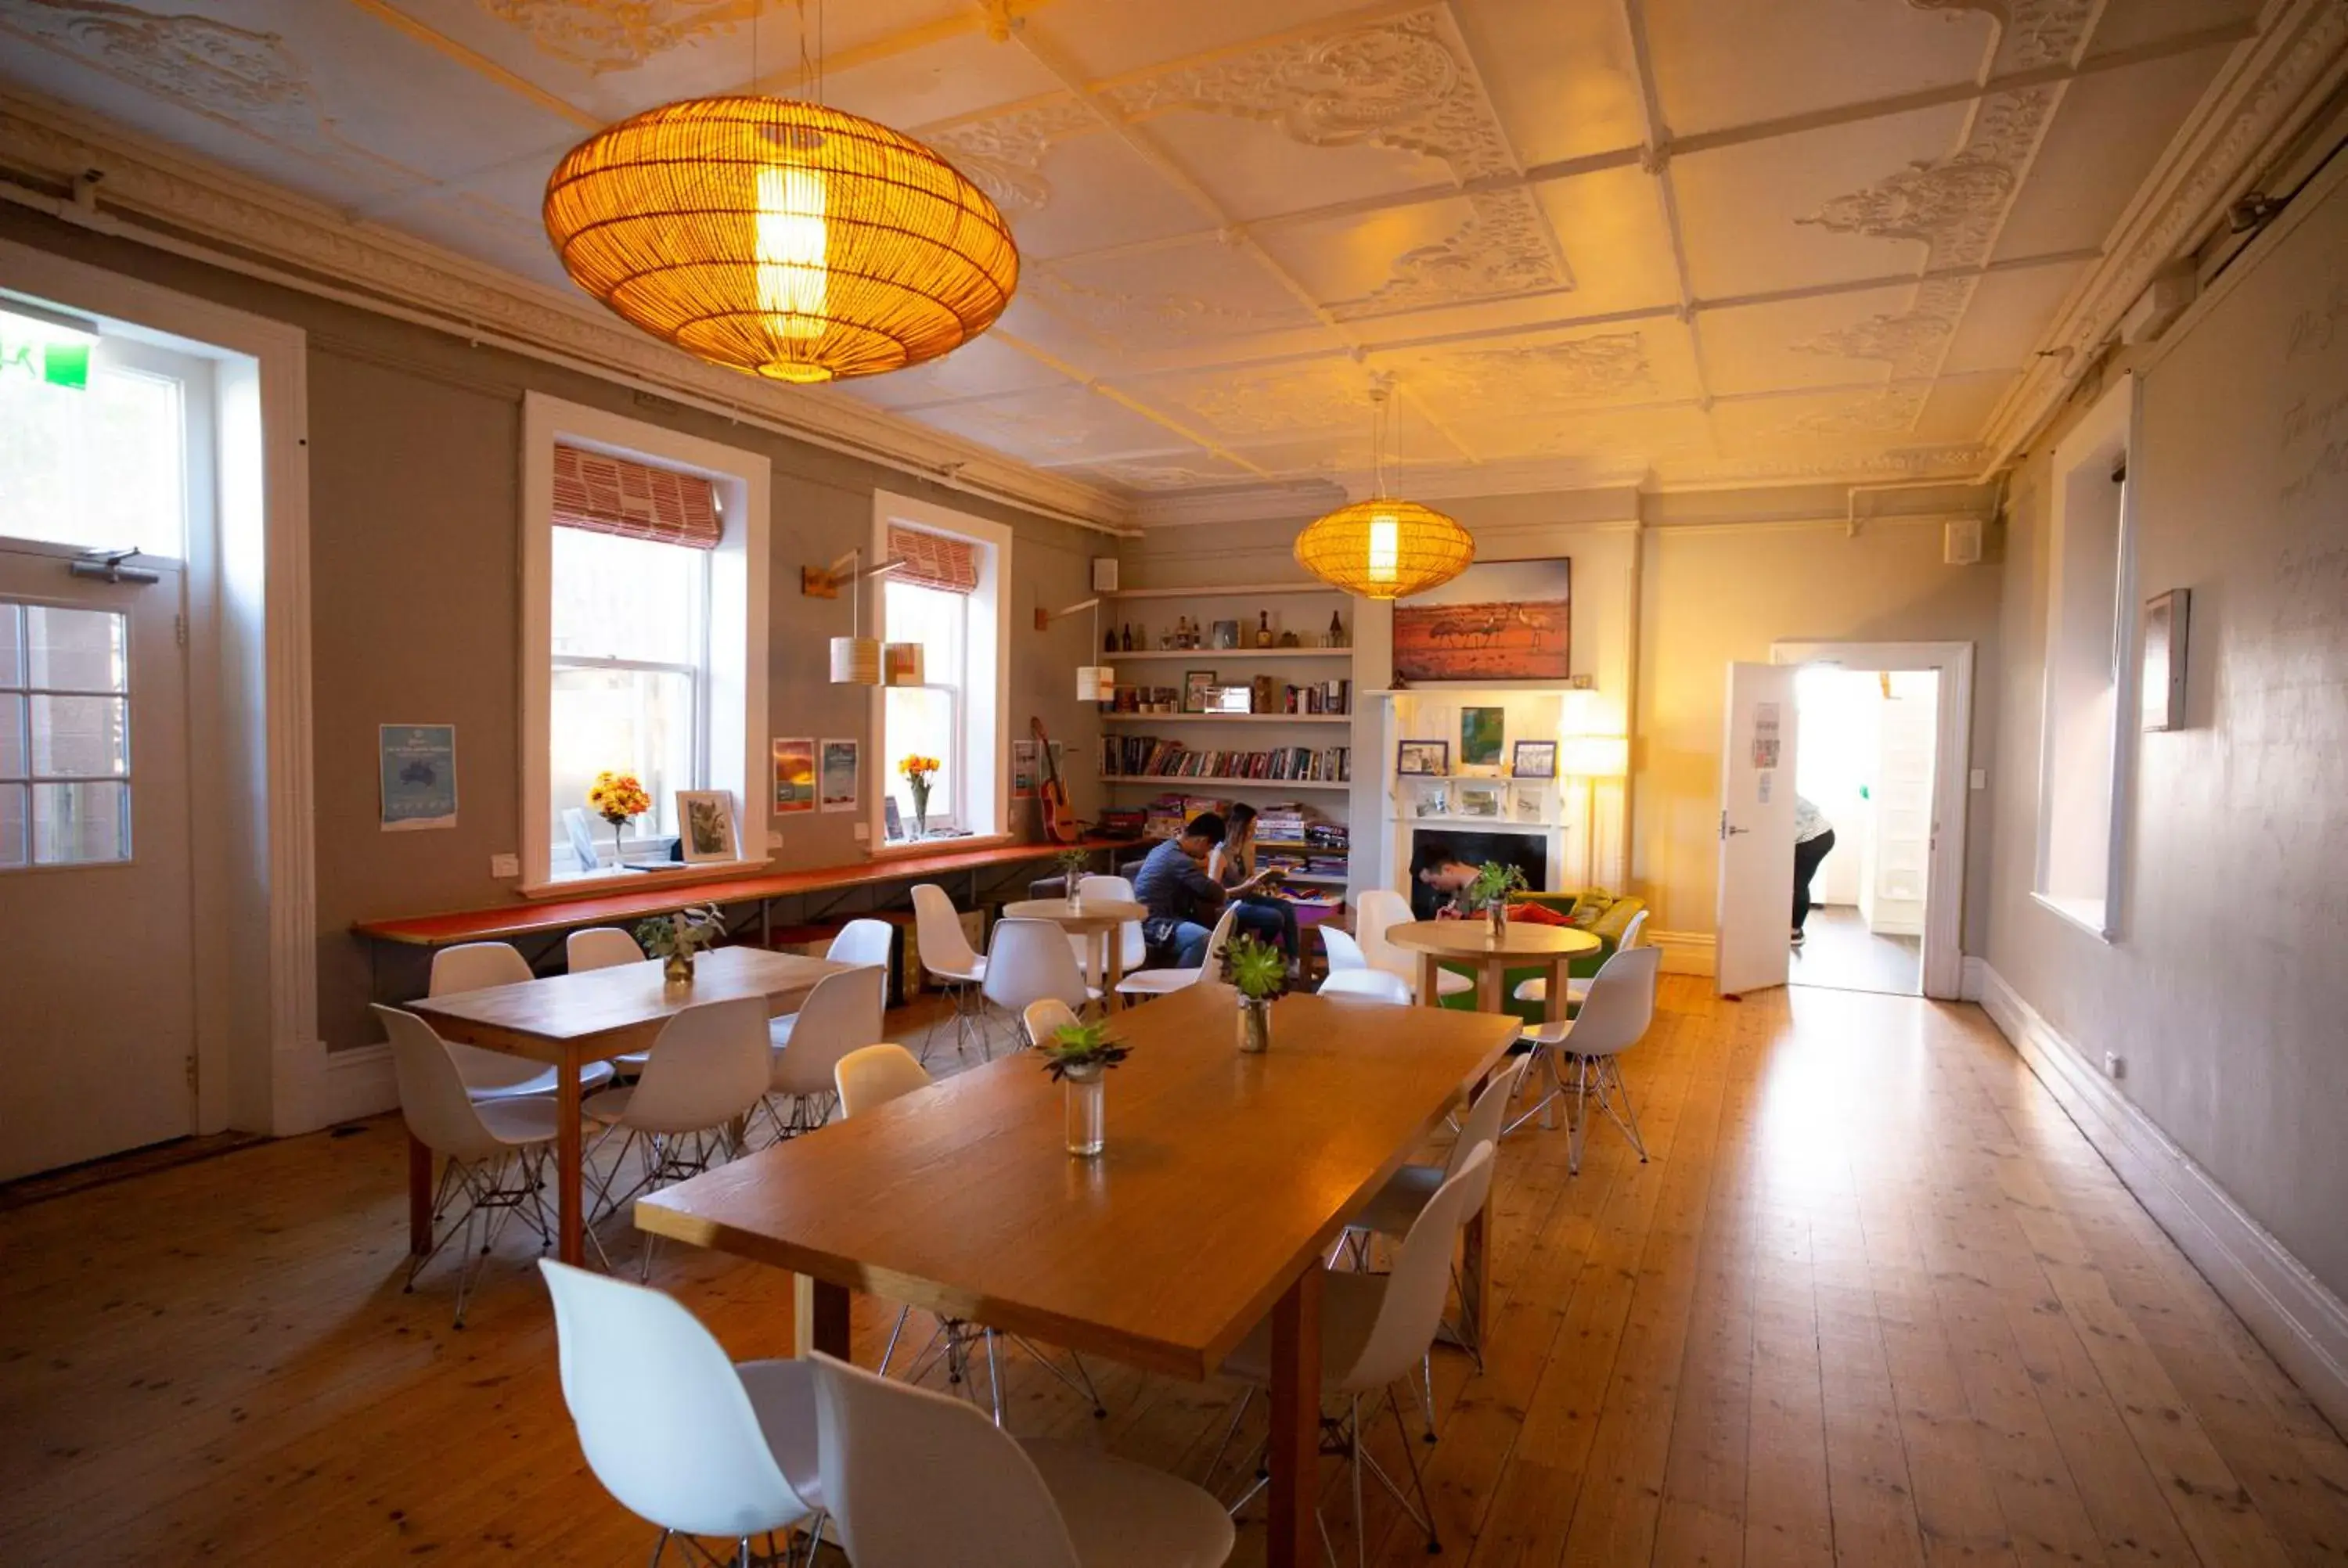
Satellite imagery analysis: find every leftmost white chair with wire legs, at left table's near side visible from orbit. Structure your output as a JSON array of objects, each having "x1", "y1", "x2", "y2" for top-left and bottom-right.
[{"x1": 376, "y1": 1005, "x2": 561, "y2": 1329}]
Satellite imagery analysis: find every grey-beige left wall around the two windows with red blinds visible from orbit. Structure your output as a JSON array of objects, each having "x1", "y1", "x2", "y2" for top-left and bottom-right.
[{"x1": 0, "y1": 207, "x2": 1111, "y2": 1047}]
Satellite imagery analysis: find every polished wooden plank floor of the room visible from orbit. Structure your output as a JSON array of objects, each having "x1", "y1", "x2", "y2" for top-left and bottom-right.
[{"x1": 0, "y1": 979, "x2": 2348, "y2": 1568}]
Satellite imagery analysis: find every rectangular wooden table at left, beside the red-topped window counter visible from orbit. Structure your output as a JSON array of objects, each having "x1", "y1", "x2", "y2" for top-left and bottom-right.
[{"x1": 406, "y1": 946, "x2": 855, "y2": 1263}]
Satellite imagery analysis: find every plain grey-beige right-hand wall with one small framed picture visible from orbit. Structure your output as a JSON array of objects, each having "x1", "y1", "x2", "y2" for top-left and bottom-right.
[{"x1": 1989, "y1": 169, "x2": 2348, "y2": 1296}]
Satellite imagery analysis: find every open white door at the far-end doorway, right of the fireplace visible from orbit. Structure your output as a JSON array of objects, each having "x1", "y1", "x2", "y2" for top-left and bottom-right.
[{"x1": 1712, "y1": 664, "x2": 1799, "y2": 995}]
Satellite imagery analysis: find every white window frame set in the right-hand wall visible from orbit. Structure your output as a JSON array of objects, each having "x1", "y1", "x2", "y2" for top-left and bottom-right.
[{"x1": 2031, "y1": 373, "x2": 2144, "y2": 941}]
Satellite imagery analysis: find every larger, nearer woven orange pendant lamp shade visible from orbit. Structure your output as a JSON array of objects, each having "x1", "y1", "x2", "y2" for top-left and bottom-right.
[{"x1": 559, "y1": 96, "x2": 1019, "y2": 383}]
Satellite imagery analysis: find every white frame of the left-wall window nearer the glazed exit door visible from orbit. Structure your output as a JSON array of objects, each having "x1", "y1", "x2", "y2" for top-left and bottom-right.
[{"x1": 519, "y1": 392, "x2": 772, "y2": 897}]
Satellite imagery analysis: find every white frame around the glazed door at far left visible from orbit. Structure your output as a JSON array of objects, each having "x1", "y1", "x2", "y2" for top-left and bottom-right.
[{"x1": 0, "y1": 239, "x2": 329, "y2": 1134}]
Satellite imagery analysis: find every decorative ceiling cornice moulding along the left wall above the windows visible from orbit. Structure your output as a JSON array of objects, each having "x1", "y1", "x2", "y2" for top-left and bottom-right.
[{"x1": 0, "y1": 92, "x2": 1129, "y2": 530}]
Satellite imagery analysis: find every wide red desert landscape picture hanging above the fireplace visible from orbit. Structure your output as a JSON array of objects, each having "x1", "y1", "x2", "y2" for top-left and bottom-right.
[{"x1": 1395, "y1": 561, "x2": 1573, "y2": 685}]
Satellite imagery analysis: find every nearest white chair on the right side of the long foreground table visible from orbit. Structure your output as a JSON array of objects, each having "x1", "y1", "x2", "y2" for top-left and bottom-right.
[{"x1": 1207, "y1": 1143, "x2": 1493, "y2": 1563}]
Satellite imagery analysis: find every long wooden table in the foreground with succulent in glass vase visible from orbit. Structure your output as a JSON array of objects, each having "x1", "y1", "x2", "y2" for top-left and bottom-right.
[{"x1": 636, "y1": 984, "x2": 1519, "y2": 1568}]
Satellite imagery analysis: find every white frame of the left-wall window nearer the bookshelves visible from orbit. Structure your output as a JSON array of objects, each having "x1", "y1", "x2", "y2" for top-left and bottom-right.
[{"x1": 857, "y1": 491, "x2": 1014, "y2": 854}]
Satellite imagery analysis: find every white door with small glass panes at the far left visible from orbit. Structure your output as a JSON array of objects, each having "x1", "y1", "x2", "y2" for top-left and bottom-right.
[{"x1": 0, "y1": 540, "x2": 195, "y2": 1178}]
